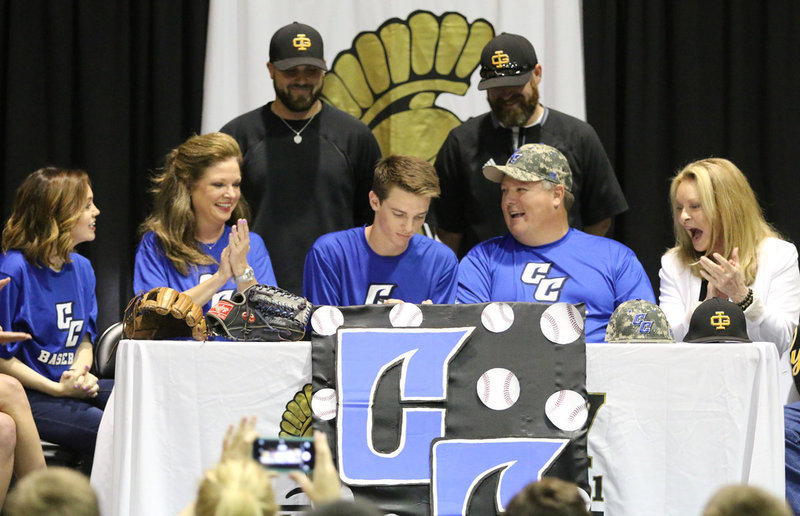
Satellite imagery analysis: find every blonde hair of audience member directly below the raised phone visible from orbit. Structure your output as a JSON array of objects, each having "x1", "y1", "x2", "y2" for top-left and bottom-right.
[{"x1": 194, "y1": 459, "x2": 278, "y2": 516}]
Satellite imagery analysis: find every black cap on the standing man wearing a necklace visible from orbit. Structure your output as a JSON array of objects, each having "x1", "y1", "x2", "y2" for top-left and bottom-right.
[{"x1": 269, "y1": 22, "x2": 328, "y2": 71}]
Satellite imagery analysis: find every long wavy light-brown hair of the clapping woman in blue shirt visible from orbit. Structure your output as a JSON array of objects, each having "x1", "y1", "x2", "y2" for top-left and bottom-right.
[{"x1": 140, "y1": 133, "x2": 250, "y2": 276}]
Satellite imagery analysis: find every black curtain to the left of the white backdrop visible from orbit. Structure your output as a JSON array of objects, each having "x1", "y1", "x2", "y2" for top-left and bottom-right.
[{"x1": 0, "y1": 0, "x2": 208, "y2": 331}]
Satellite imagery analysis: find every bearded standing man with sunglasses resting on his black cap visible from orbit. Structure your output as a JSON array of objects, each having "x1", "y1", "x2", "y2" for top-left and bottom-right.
[{"x1": 434, "y1": 33, "x2": 628, "y2": 257}]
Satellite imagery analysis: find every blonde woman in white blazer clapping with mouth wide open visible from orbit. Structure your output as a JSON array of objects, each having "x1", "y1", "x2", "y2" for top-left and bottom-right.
[{"x1": 659, "y1": 158, "x2": 800, "y2": 355}]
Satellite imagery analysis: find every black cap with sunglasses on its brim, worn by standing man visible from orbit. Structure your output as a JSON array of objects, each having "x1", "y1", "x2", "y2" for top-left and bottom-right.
[{"x1": 478, "y1": 32, "x2": 539, "y2": 90}]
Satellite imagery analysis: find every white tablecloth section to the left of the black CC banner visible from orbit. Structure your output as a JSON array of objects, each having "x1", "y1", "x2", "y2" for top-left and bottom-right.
[{"x1": 91, "y1": 340, "x2": 311, "y2": 516}]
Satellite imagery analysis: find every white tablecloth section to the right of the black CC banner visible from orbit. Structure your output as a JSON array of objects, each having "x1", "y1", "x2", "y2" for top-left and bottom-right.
[{"x1": 586, "y1": 343, "x2": 784, "y2": 516}]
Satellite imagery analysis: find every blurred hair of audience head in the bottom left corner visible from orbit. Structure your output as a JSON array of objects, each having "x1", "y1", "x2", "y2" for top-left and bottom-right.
[{"x1": 3, "y1": 467, "x2": 100, "y2": 516}]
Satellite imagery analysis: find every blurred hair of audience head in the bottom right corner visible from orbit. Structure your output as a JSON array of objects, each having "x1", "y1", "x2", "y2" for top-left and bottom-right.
[{"x1": 703, "y1": 485, "x2": 792, "y2": 516}]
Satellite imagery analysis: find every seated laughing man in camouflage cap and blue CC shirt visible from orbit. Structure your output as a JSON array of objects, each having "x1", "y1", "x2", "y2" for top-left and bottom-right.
[{"x1": 457, "y1": 143, "x2": 655, "y2": 342}]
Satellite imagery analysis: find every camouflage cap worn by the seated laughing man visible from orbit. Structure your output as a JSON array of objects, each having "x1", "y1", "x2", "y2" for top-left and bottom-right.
[{"x1": 483, "y1": 143, "x2": 572, "y2": 192}]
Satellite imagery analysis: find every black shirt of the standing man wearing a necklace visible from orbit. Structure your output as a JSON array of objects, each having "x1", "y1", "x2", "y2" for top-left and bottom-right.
[{"x1": 221, "y1": 103, "x2": 381, "y2": 294}]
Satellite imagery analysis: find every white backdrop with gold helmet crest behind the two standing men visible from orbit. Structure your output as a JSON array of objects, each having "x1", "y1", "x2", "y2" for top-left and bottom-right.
[{"x1": 202, "y1": 0, "x2": 585, "y2": 147}]
